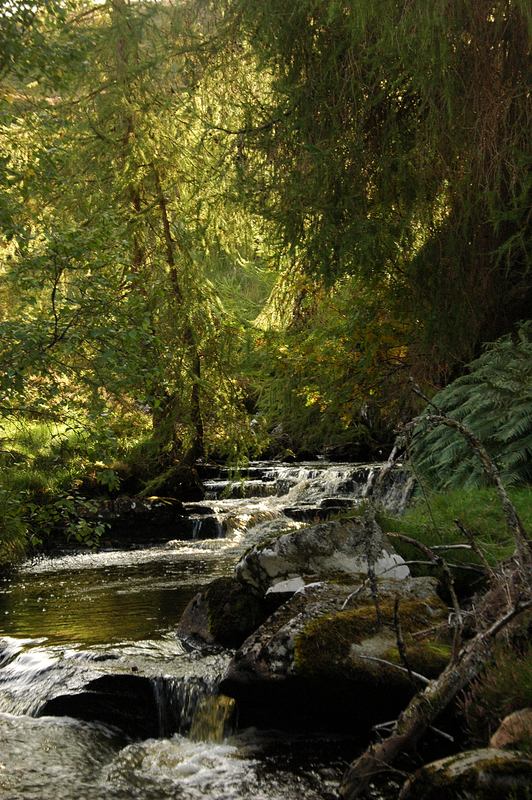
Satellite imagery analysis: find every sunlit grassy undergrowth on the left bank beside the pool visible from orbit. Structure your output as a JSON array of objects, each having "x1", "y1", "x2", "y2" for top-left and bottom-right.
[{"x1": 0, "y1": 419, "x2": 150, "y2": 569}]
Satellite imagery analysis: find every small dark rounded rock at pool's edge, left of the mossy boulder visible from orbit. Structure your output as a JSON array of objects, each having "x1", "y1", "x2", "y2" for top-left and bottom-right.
[{"x1": 177, "y1": 578, "x2": 270, "y2": 647}]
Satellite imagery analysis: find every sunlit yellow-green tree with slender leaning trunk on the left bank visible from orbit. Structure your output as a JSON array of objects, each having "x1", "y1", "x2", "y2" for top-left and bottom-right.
[{"x1": 3, "y1": 0, "x2": 266, "y2": 465}]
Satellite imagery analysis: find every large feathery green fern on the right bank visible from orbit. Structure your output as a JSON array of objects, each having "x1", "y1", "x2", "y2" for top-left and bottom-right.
[{"x1": 412, "y1": 322, "x2": 532, "y2": 488}]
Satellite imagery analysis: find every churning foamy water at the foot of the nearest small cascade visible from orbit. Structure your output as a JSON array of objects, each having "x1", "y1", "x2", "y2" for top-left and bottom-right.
[{"x1": 0, "y1": 713, "x2": 336, "y2": 800}]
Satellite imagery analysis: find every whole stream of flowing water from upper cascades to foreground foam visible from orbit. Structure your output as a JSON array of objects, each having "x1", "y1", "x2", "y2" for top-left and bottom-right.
[{"x1": 0, "y1": 462, "x2": 412, "y2": 800}]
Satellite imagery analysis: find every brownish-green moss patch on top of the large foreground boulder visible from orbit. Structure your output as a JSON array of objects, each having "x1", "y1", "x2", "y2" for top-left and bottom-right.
[{"x1": 294, "y1": 597, "x2": 445, "y2": 680}]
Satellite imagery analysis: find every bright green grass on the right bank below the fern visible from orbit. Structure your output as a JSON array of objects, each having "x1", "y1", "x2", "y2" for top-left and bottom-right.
[{"x1": 380, "y1": 488, "x2": 532, "y2": 565}]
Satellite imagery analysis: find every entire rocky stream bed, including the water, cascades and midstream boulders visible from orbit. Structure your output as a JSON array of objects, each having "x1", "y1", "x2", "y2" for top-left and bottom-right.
[{"x1": 0, "y1": 462, "x2": 528, "y2": 800}]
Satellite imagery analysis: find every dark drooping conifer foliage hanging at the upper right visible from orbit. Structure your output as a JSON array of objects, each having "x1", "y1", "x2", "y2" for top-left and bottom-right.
[{"x1": 222, "y1": 0, "x2": 531, "y2": 383}]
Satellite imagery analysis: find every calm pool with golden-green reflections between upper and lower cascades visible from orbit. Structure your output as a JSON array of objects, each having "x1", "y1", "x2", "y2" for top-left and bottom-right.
[{"x1": 0, "y1": 540, "x2": 234, "y2": 646}]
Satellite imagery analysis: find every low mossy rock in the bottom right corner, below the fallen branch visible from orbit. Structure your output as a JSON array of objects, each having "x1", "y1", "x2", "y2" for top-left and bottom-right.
[{"x1": 399, "y1": 748, "x2": 532, "y2": 800}]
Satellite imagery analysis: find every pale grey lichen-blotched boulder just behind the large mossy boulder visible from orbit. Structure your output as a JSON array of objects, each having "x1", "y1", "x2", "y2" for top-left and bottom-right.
[{"x1": 236, "y1": 518, "x2": 410, "y2": 594}]
